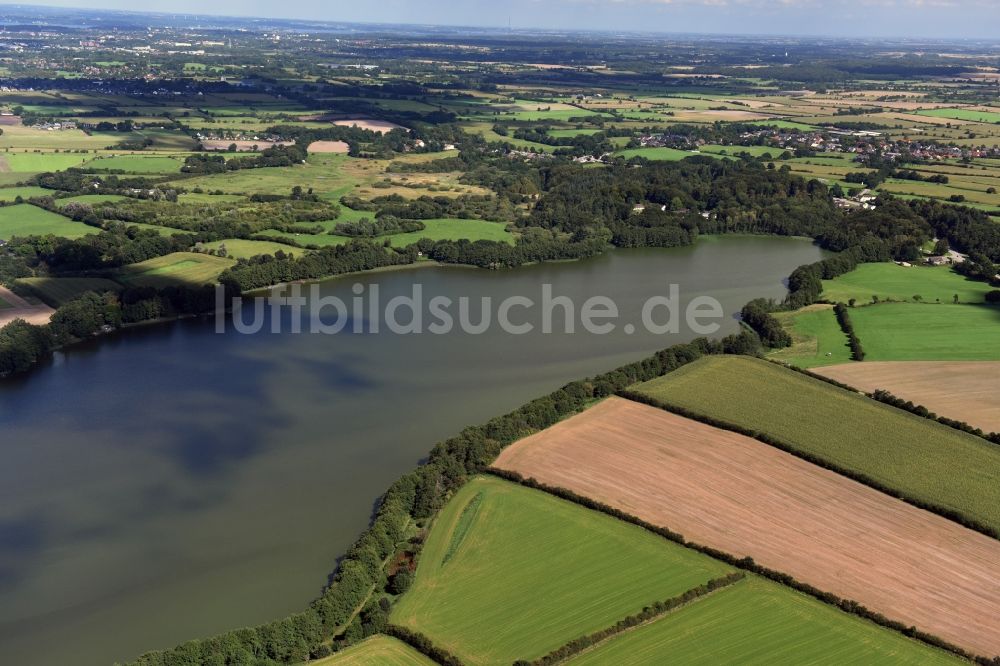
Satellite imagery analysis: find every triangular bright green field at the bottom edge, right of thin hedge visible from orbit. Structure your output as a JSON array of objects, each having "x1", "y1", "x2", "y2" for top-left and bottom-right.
[{"x1": 566, "y1": 576, "x2": 963, "y2": 666}]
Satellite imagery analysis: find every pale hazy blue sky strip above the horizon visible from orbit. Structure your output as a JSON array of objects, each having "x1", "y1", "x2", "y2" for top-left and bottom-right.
[{"x1": 9, "y1": 0, "x2": 1000, "y2": 42}]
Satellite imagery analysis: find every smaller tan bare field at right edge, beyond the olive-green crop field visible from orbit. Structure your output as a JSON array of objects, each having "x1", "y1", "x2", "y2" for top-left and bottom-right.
[{"x1": 813, "y1": 361, "x2": 1000, "y2": 434}]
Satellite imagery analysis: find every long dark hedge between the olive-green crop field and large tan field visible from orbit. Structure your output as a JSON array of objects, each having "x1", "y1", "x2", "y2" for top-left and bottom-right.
[{"x1": 618, "y1": 389, "x2": 1000, "y2": 539}]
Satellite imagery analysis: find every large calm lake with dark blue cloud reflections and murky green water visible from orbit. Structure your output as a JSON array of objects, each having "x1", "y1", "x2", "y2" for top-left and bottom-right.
[{"x1": 0, "y1": 237, "x2": 822, "y2": 666}]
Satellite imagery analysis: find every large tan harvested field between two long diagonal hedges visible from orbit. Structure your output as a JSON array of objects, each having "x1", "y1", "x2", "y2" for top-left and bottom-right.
[{"x1": 495, "y1": 398, "x2": 1000, "y2": 656}]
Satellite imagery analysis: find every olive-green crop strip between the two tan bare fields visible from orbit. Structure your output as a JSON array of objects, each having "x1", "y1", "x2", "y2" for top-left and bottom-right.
[{"x1": 635, "y1": 356, "x2": 1000, "y2": 529}]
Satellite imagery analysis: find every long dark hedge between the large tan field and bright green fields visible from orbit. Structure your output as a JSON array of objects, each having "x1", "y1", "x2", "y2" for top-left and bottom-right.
[{"x1": 486, "y1": 467, "x2": 988, "y2": 666}]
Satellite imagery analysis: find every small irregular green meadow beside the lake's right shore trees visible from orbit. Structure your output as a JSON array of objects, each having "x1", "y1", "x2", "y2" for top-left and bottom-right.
[{"x1": 769, "y1": 305, "x2": 851, "y2": 368}]
